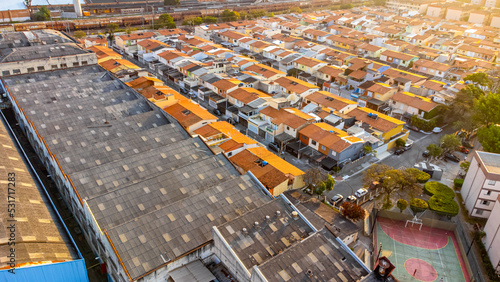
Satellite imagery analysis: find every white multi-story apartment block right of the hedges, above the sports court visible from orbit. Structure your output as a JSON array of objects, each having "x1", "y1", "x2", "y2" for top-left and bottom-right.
[{"x1": 460, "y1": 151, "x2": 500, "y2": 218}]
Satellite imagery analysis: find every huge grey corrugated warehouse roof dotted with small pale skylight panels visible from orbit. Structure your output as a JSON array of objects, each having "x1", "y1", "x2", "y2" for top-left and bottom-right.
[{"x1": 4, "y1": 65, "x2": 270, "y2": 279}]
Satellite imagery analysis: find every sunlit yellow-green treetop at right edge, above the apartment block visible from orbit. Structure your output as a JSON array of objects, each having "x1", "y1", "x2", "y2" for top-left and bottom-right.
[{"x1": 473, "y1": 93, "x2": 500, "y2": 127}]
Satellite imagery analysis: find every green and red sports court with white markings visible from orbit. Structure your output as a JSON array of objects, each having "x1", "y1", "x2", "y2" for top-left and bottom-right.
[{"x1": 375, "y1": 217, "x2": 470, "y2": 282}]
